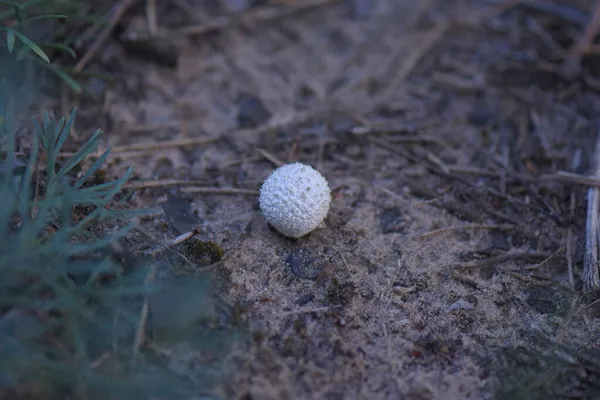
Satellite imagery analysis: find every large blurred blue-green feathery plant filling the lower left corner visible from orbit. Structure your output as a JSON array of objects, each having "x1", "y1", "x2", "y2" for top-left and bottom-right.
[{"x1": 0, "y1": 105, "x2": 234, "y2": 400}]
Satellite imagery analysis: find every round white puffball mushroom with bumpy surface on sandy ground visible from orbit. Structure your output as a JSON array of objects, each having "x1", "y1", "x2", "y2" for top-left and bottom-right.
[{"x1": 259, "y1": 163, "x2": 331, "y2": 238}]
